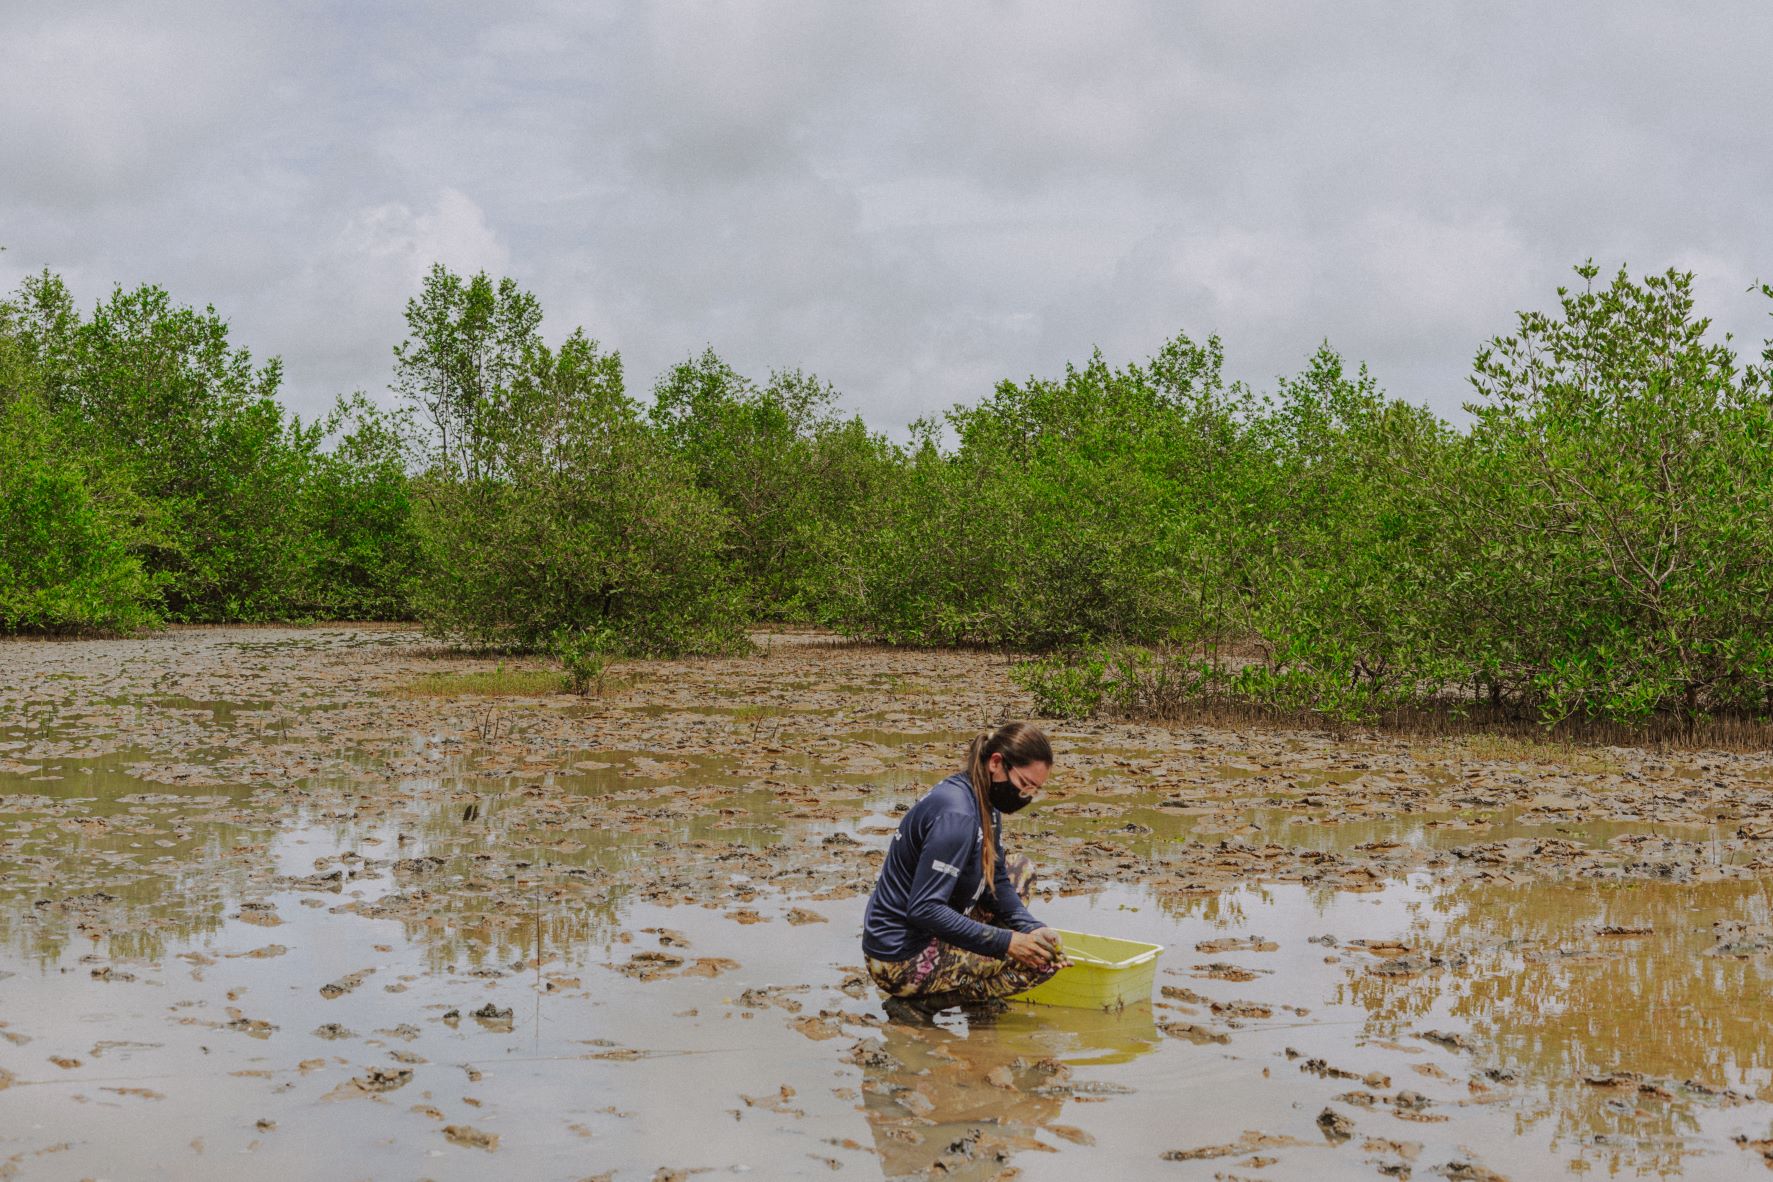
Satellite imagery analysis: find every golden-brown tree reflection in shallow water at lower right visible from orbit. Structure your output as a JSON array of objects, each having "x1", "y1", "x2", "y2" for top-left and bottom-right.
[{"x1": 1339, "y1": 883, "x2": 1773, "y2": 1173}]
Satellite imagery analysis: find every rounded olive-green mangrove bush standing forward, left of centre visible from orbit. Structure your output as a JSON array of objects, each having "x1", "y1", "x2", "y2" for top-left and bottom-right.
[{"x1": 402, "y1": 268, "x2": 745, "y2": 656}]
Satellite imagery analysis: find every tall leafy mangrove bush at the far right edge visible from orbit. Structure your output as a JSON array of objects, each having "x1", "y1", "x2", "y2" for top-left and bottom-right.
[{"x1": 1457, "y1": 264, "x2": 1773, "y2": 721}]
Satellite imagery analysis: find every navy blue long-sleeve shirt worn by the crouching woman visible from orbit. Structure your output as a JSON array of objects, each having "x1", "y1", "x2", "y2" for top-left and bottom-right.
[{"x1": 862, "y1": 773, "x2": 1041, "y2": 960}]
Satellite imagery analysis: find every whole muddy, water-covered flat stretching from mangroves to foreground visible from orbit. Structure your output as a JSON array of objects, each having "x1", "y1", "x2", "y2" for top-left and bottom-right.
[{"x1": 0, "y1": 629, "x2": 1773, "y2": 1178}]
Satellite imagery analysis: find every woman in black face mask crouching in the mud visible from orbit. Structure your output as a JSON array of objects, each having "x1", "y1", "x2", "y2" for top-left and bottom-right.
[{"x1": 862, "y1": 723, "x2": 1066, "y2": 1012}]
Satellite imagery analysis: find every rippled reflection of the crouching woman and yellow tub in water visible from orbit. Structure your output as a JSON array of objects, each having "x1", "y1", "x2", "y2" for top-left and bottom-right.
[{"x1": 855, "y1": 1005, "x2": 1160, "y2": 1178}]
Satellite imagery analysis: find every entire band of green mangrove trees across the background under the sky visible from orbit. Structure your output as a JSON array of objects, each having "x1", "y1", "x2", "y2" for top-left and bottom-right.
[{"x1": 0, "y1": 249, "x2": 1773, "y2": 725}]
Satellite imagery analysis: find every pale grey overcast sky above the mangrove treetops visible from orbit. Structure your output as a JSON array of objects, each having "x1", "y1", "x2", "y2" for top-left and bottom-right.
[{"x1": 0, "y1": 0, "x2": 1773, "y2": 429}]
